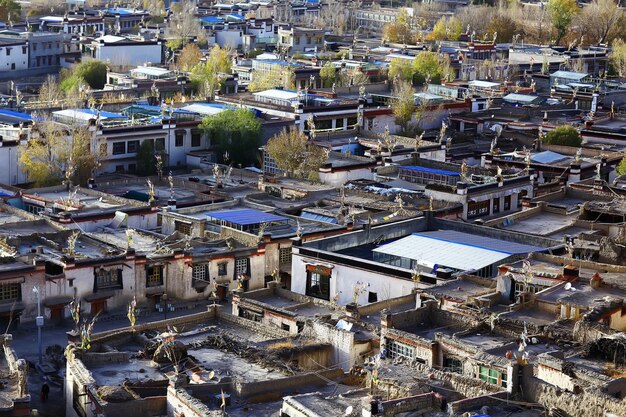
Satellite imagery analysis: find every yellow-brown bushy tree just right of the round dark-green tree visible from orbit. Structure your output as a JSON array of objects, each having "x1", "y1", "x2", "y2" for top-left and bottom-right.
[{"x1": 265, "y1": 128, "x2": 326, "y2": 179}]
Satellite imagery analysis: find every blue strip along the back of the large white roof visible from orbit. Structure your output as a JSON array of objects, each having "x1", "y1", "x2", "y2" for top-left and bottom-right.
[{"x1": 413, "y1": 230, "x2": 545, "y2": 255}]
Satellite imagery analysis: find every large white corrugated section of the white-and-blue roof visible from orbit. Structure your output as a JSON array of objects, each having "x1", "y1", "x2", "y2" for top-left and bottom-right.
[{"x1": 374, "y1": 234, "x2": 524, "y2": 270}]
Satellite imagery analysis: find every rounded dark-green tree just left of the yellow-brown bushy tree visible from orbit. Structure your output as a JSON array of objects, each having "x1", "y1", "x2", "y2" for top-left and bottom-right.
[{"x1": 200, "y1": 109, "x2": 261, "y2": 166}]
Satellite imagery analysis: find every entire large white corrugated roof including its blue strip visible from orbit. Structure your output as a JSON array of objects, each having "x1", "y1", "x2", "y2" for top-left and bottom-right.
[{"x1": 374, "y1": 230, "x2": 543, "y2": 270}]
